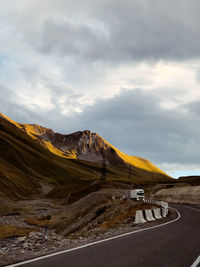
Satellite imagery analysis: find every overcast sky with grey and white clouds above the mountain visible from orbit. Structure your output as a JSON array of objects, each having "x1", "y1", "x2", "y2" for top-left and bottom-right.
[{"x1": 0, "y1": 0, "x2": 200, "y2": 177}]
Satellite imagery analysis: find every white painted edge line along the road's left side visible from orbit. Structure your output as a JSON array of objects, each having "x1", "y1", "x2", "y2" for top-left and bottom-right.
[{"x1": 5, "y1": 208, "x2": 181, "y2": 267}]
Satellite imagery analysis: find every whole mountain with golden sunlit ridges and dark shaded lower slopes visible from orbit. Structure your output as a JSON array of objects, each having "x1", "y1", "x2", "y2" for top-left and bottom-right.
[{"x1": 0, "y1": 113, "x2": 172, "y2": 199}]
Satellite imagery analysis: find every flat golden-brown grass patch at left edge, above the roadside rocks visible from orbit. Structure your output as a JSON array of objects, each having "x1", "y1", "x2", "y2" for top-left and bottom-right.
[{"x1": 0, "y1": 225, "x2": 38, "y2": 239}]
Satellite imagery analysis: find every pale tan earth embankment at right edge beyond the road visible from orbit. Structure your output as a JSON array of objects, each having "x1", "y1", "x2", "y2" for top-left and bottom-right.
[{"x1": 153, "y1": 186, "x2": 200, "y2": 204}]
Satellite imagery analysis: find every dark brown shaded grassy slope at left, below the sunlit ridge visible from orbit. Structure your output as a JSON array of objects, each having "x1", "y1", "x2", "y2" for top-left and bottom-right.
[{"x1": 0, "y1": 118, "x2": 99, "y2": 198}]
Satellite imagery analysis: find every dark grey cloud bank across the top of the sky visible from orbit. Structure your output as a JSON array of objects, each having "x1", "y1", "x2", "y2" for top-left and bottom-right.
[{"x1": 22, "y1": 0, "x2": 200, "y2": 63}]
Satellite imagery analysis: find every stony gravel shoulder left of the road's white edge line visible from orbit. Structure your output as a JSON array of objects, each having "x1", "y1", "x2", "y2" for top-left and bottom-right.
[{"x1": 0, "y1": 209, "x2": 177, "y2": 266}]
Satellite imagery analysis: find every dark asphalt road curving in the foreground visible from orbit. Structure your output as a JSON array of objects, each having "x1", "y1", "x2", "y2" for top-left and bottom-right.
[{"x1": 10, "y1": 204, "x2": 200, "y2": 267}]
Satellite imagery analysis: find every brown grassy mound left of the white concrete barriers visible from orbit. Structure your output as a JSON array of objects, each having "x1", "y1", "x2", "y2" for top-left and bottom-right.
[{"x1": 49, "y1": 193, "x2": 156, "y2": 238}]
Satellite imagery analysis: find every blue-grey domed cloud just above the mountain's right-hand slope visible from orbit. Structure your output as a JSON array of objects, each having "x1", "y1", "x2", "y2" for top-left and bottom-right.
[{"x1": 63, "y1": 89, "x2": 200, "y2": 164}]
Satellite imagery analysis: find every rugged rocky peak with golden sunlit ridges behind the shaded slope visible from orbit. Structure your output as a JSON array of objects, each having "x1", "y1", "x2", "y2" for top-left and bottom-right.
[{"x1": 0, "y1": 114, "x2": 171, "y2": 180}]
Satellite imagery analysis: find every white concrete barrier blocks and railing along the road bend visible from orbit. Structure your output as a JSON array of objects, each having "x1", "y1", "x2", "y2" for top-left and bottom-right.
[{"x1": 135, "y1": 199, "x2": 168, "y2": 224}]
